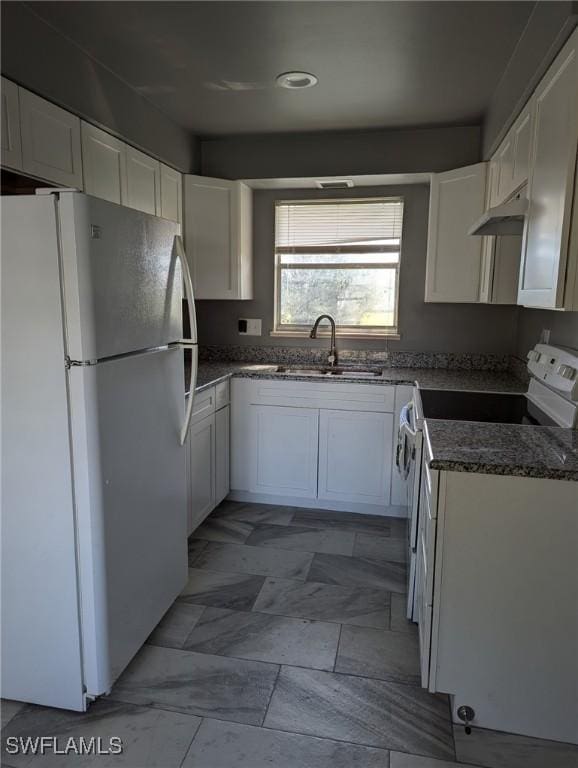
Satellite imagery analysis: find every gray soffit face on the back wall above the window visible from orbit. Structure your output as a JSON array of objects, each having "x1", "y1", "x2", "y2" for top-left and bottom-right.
[{"x1": 201, "y1": 126, "x2": 481, "y2": 179}]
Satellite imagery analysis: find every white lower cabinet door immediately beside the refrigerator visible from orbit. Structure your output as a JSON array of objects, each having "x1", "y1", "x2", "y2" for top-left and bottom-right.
[{"x1": 189, "y1": 414, "x2": 215, "y2": 531}]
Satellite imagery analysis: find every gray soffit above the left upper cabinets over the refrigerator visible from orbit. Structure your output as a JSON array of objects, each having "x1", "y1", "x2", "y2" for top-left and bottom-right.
[{"x1": 1, "y1": 2, "x2": 199, "y2": 173}]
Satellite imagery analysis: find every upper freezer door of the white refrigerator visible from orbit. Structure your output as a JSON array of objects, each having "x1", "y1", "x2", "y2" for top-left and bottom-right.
[{"x1": 58, "y1": 192, "x2": 183, "y2": 360}]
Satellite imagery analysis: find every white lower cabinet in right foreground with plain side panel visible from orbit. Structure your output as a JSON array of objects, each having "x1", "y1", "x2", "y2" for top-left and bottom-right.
[{"x1": 416, "y1": 456, "x2": 578, "y2": 743}]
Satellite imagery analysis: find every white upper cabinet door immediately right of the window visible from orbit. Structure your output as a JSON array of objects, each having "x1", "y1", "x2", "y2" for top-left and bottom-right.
[{"x1": 425, "y1": 163, "x2": 486, "y2": 302}]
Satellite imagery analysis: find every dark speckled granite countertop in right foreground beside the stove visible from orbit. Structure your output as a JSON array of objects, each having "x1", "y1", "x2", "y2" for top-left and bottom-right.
[{"x1": 425, "y1": 419, "x2": 578, "y2": 481}]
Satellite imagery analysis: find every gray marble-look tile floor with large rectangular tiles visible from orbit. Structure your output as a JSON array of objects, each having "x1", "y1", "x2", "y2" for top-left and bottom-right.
[{"x1": 1, "y1": 502, "x2": 578, "y2": 768}]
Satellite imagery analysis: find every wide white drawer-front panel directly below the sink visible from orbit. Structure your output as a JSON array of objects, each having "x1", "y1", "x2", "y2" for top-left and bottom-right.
[{"x1": 251, "y1": 379, "x2": 395, "y2": 413}]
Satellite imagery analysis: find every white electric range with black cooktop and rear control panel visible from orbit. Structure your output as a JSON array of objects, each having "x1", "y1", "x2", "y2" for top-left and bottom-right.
[{"x1": 397, "y1": 344, "x2": 578, "y2": 621}]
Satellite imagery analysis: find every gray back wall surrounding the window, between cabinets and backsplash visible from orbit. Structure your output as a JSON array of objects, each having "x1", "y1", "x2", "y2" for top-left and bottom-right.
[{"x1": 197, "y1": 185, "x2": 518, "y2": 353}]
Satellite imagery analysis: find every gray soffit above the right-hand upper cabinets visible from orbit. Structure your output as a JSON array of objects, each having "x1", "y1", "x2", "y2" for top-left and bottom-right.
[{"x1": 483, "y1": 0, "x2": 578, "y2": 159}]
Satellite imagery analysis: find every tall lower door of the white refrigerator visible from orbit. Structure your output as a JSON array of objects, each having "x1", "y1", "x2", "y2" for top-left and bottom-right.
[{"x1": 69, "y1": 347, "x2": 187, "y2": 695}]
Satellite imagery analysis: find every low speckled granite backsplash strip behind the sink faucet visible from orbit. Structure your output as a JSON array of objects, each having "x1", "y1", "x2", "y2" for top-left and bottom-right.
[{"x1": 199, "y1": 345, "x2": 510, "y2": 371}]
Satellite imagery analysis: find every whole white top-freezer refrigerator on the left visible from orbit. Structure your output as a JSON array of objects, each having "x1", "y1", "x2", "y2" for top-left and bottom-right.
[{"x1": 1, "y1": 190, "x2": 197, "y2": 710}]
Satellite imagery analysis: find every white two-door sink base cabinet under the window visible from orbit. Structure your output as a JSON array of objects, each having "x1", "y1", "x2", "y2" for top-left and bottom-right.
[{"x1": 231, "y1": 379, "x2": 396, "y2": 514}]
